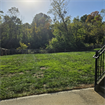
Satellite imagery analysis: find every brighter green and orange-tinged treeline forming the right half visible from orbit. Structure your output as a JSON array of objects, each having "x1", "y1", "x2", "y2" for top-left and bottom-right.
[{"x1": 47, "y1": 11, "x2": 105, "y2": 51}]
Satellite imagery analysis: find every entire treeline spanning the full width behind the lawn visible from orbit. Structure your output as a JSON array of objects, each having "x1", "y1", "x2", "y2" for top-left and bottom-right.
[{"x1": 0, "y1": 3, "x2": 105, "y2": 52}]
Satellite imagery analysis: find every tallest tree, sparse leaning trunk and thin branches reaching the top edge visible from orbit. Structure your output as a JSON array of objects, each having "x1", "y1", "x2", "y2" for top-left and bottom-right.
[{"x1": 47, "y1": 0, "x2": 74, "y2": 51}]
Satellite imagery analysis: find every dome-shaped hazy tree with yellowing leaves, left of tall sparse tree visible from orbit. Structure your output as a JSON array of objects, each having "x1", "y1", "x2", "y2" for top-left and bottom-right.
[{"x1": 30, "y1": 13, "x2": 53, "y2": 49}]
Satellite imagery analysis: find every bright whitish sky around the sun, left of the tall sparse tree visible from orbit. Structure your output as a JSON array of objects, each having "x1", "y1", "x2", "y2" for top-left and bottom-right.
[{"x1": 0, "y1": 0, "x2": 50, "y2": 23}]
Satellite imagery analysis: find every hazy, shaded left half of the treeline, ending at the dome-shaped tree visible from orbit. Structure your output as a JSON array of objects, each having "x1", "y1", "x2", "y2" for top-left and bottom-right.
[{"x1": 0, "y1": 7, "x2": 53, "y2": 49}]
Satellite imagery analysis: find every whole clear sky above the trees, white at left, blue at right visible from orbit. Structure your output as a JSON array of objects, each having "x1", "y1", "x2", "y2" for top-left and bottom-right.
[{"x1": 0, "y1": 0, "x2": 105, "y2": 23}]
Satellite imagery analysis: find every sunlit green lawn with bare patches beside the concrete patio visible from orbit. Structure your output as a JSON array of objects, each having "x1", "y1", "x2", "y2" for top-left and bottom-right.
[{"x1": 0, "y1": 52, "x2": 95, "y2": 100}]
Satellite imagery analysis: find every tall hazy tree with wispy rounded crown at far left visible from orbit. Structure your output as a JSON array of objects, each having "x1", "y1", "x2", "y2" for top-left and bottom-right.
[{"x1": 0, "y1": 7, "x2": 21, "y2": 48}]
